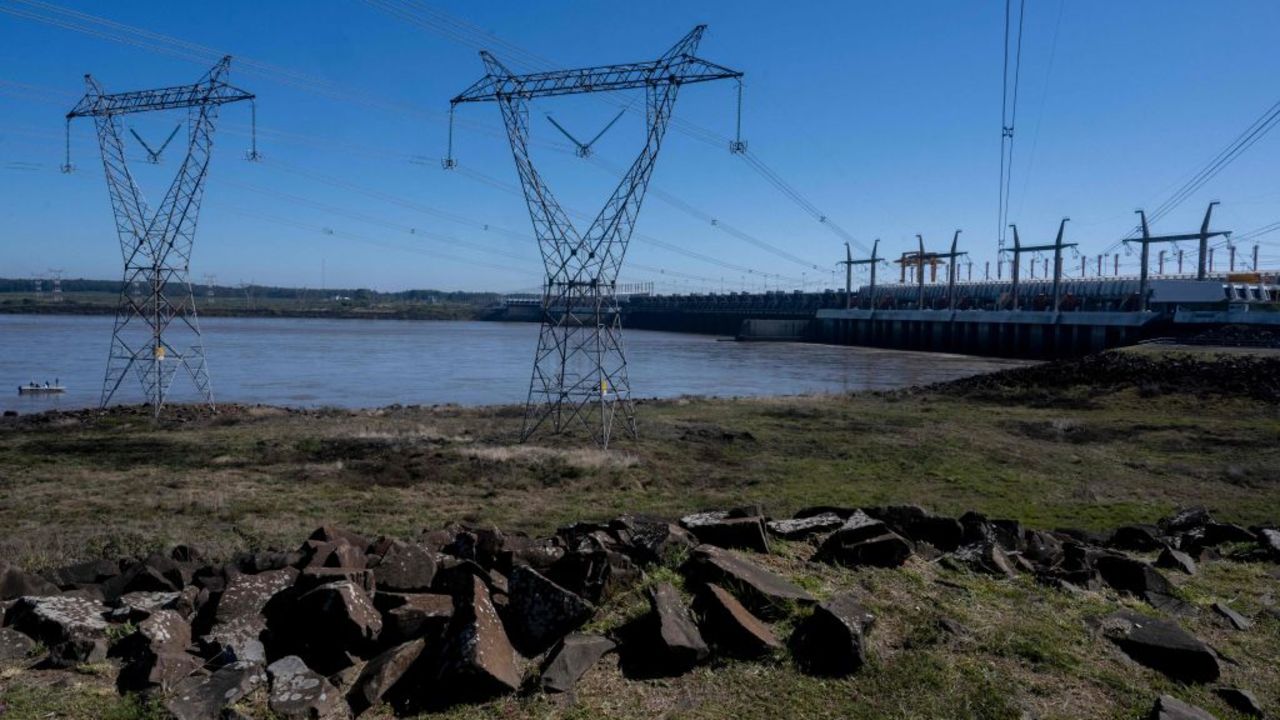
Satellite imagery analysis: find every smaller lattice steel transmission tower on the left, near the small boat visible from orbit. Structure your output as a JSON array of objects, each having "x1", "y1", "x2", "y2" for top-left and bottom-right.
[{"x1": 64, "y1": 56, "x2": 256, "y2": 416}]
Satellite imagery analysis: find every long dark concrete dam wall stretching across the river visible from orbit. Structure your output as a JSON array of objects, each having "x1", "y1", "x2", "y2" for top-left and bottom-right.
[{"x1": 493, "y1": 274, "x2": 1280, "y2": 357}]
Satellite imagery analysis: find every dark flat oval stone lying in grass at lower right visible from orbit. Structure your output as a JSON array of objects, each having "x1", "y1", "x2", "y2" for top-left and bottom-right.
[{"x1": 1100, "y1": 610, "x2": 1221, "y2": 683}]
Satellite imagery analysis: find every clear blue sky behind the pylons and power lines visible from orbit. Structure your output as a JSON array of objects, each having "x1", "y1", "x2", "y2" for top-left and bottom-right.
[{"x1": 0, "y1": 0, "x2": 1280, "y2": 291}]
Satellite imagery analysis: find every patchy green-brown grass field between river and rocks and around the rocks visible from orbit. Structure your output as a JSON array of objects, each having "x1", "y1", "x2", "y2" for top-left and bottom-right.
[{"x1": 0, "y1": 351, "x2": 1280, "y2": 720}]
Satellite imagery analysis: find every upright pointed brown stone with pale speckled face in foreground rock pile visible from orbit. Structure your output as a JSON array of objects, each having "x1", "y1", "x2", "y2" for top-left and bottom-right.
[{"x1": 439, "y1": 578, "x2": 521, "y2": 700}]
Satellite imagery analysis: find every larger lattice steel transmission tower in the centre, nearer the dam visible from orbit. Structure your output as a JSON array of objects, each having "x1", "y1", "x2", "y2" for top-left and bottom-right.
[{"x1": 444, "y1": 26, "x2": 742, "y2": 447}]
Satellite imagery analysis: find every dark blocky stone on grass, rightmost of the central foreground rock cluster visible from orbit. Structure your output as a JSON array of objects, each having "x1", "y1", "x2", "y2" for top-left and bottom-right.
[{"x1": 790, "y1": 594, "x2": 874, "y2": 676}]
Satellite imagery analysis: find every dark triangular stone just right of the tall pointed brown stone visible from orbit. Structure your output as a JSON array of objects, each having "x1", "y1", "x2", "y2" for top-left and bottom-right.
[{"x1": 507, "y1": 565, "x2": 595, "y2": 656}]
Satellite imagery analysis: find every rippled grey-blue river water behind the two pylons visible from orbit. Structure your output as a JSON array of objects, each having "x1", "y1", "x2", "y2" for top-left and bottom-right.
[{"x1": 0, "y1": 315, "x2": 1025, "y2": 413}]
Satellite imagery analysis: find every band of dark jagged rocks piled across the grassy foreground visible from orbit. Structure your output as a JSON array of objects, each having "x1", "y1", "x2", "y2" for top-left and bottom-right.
[{"x1": 0, "y1": 506, "x2": 1280, "y2": 720}]
